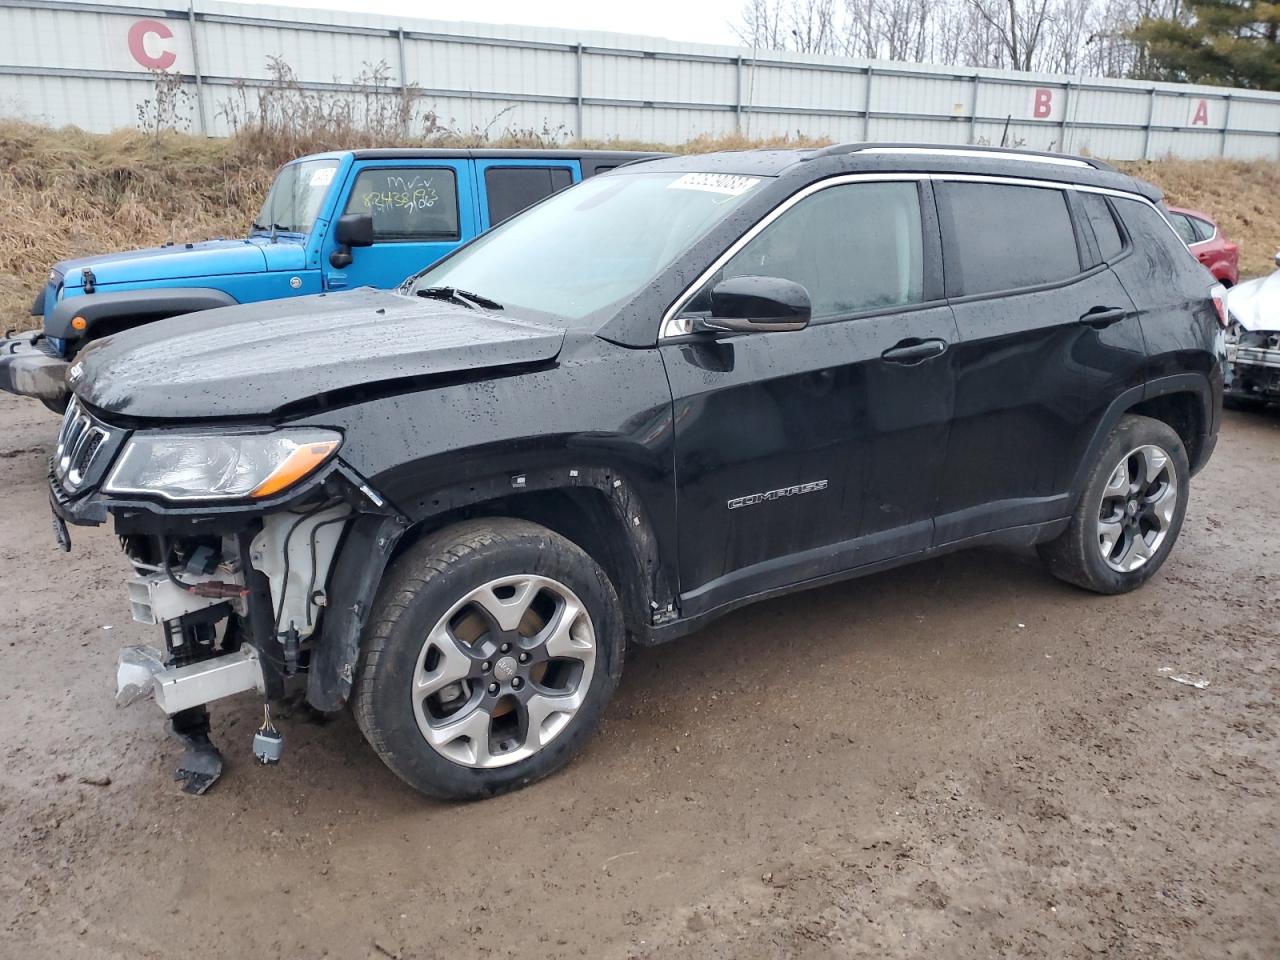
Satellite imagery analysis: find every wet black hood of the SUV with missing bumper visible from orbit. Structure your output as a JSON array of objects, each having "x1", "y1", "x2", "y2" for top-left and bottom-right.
[{"x1": 68, "y1": 288, "x2": 564, "y2": 420}]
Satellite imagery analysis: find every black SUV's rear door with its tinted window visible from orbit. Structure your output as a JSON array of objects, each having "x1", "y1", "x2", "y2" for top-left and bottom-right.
[{"x1": 936, "y1": 178, "x2": 1143, "y2": 544}]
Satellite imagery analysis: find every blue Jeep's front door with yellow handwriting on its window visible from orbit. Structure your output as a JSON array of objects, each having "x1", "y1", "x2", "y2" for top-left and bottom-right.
[{"x1": 321, "y1": 160, "x2": 479, "y2": 289}]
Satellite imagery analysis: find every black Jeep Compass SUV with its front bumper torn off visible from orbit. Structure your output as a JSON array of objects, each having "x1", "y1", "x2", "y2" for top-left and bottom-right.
[{"x1": 50, "y1": 145, "x2": 1224, "y2": 797}]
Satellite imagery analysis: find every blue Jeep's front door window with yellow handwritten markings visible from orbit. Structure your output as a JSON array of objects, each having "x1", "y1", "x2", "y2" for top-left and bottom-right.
[{"x1": 343, "y1": 166, "x2": 461, "y2": 243}]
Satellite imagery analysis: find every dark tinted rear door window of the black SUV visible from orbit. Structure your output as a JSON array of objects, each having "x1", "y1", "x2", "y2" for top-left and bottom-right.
[{"x1": 942, "y1": 183, "x2": 1080, "y2": 297}]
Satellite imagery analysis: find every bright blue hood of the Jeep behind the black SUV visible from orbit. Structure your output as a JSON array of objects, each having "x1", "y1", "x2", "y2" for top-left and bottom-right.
[{"x1": 54, "y1": 237, "x2": 289, "y2": 289}]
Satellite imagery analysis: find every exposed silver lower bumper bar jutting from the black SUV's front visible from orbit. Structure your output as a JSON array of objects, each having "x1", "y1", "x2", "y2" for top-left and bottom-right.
[{"x1": 115, "y1": 645, "x2": 266, "y2": 717}]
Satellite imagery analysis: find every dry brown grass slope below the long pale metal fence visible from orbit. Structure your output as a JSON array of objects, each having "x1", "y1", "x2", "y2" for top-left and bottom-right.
[{"x1": 0, "y1": 122, "x2": 1280, "y2": 329}]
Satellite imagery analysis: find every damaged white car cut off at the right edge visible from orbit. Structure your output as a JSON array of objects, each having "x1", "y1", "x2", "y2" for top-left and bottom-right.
[{"x1": 1226, "y1": 253, "x2": 1280, "y2": 403}]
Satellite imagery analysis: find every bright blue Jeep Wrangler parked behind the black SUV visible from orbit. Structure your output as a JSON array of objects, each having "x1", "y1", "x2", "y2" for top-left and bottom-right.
[{"x1": 0, "y1": 148, "x2": 660, "y2": 411}]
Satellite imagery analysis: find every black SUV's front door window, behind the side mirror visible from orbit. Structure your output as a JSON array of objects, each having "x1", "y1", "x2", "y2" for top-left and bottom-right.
[{"x1": 690, "y1": 182, "x2": 924, "y2": 319}]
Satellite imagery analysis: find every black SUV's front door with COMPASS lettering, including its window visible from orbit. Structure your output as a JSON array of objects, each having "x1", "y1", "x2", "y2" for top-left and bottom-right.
[{"x1": 662, "y1": 180, "x2": 955, "y2": 616}]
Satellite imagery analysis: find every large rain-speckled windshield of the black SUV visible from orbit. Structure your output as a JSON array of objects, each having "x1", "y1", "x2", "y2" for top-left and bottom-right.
[{"x1": 401, "y1": 172, "x2": 760, "y2": 320}]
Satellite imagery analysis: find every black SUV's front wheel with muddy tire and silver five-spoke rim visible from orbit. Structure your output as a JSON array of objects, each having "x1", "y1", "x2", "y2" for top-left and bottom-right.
[{"x1": 352, "y1": 518, "x2": 625, "y2": 800}]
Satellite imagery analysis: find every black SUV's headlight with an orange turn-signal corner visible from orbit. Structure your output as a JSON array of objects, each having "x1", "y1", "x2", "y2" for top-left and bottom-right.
[{"x1": 104, "y1": 428, "x2": 342, "y2": 500}]
